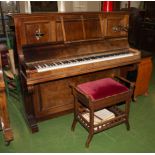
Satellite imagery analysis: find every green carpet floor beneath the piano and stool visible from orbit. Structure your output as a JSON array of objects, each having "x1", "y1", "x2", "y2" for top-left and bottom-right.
[{"x1": 0, "y1": 60, "x2": 155, "y2": 153}]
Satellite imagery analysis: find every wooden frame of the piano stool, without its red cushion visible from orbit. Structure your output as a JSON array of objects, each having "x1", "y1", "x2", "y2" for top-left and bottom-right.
[{"x1": 71, "y1": 76, "x2": 134, "y2": 147}]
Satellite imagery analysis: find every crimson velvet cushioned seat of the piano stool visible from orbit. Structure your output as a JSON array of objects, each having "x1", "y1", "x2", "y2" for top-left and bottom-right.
[{"x1": 77, "y1": 78, "x2": 128, "y2": 101}]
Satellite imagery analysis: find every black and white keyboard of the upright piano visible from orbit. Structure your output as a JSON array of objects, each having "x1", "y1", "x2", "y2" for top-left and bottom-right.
[{"x1": 34, "y1": 51, "x2": 134, "y2": 72}]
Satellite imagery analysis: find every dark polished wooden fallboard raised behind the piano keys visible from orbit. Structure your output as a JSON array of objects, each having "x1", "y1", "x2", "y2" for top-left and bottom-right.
[{"x1": 23, "y1": 38, "x2": 129, "y2": 63}]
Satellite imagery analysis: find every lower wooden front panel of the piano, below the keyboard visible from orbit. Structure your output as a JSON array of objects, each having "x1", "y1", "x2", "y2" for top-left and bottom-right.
[{"x1": 33, "y1": 68, "x2": 119, "y2": 120}]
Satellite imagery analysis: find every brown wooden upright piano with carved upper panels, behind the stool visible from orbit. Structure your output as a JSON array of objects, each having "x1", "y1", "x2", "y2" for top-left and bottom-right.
[{"x1": 12, "y1": 12, "x2": 141, "y2": 132}]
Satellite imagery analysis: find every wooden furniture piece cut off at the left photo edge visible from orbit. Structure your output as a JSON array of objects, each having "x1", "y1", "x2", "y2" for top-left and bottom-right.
[{"x1": 0, "y1": 46, "x2": 13, "y2": 145}]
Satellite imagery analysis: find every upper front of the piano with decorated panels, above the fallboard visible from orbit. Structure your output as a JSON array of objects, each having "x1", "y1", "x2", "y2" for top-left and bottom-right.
[{"x1": 13, "y1": 12, "x2": 128, "y2": 59}]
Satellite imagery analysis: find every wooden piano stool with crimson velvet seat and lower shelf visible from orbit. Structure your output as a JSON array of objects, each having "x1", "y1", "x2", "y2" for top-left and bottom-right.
[{"x1": 71, "y1": 76, "x2": 134, "y2": 147}]
